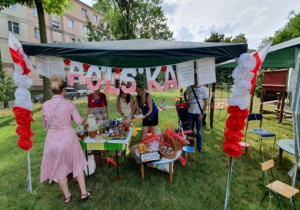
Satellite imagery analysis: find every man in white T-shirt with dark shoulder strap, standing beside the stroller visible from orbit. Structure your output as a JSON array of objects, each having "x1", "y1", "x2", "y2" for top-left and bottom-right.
[{"x1": 184, "y1": 73, "x2": 207, "y2": 153}]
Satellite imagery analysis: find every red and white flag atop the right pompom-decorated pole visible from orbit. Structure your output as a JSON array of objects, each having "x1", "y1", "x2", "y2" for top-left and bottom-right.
[{"x1": 250, "y1": 40, "x2": 273, "y2": 95}]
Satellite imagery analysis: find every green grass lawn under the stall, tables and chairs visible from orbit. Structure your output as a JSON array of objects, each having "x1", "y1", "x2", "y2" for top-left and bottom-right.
[{"x1": 0, "y1": 91, "x2": 300, "y2": 209}]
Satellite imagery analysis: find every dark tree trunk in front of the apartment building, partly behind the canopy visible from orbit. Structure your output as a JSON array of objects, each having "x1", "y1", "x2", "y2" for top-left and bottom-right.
[{"x1": 35, "y1": 0, "x2": 52, "y2": 102}]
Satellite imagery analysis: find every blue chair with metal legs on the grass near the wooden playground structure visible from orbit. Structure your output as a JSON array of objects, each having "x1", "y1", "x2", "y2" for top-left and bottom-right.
[{"x1": 245, "y1": 113, "x2": 276, "y2": 151}]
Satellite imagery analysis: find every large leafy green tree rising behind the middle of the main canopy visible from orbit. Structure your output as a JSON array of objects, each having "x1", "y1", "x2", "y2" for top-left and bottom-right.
[{"x1": 91, "y1": 0, "x2": 173, "y2": 40}]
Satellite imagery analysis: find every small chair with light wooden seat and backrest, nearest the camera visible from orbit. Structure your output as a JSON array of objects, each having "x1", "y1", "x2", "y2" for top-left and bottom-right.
[{"x1": 260, "y1": 159, "x2": 299, "y2": 209}]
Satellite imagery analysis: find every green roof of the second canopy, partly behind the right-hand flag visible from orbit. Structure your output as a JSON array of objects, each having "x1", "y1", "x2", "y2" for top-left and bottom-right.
[{"x1": 218, "y1": 37, "x2": 300, "y2": 68}]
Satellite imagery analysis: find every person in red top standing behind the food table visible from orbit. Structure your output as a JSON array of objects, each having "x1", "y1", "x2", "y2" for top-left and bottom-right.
[{"x1": 84, "y1": 80, "x2": 109, "y2": 122}]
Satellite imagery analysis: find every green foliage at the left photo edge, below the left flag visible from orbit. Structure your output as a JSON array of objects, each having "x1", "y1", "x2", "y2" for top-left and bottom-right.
[{"x1": 0, "y1": 59, "x2": 15, "y2": 108}]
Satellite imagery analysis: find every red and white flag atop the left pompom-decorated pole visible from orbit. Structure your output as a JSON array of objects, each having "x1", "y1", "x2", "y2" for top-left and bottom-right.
[{"x1": 8, "y1": 32, "x2": 32, "y2": 74}]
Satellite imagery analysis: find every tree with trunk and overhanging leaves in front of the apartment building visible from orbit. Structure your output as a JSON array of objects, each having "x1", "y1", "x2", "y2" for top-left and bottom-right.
[{"x1": 0, "y1": 0, "x2": 74, "y2": 101}]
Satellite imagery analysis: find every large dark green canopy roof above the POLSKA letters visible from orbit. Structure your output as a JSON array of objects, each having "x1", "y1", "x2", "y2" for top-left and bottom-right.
[{"x1": 23, "y1": 39, "x2": 247, "y2": 68}]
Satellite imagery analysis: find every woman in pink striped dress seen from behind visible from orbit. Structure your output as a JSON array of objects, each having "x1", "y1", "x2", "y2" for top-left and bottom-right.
[{"x1": 40, "y1": 76, "x2": 91, "y2": 204}]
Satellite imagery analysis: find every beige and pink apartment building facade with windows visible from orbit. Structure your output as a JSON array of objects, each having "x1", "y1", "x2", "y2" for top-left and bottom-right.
[{"x1": 0, "y1": 0, "x2": 109, "y2": 91}]
